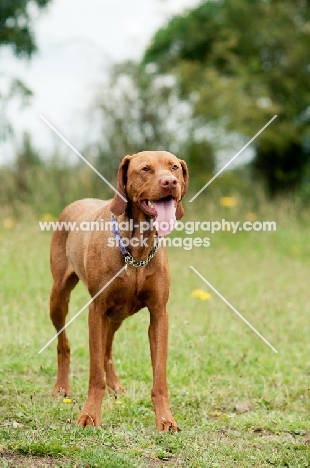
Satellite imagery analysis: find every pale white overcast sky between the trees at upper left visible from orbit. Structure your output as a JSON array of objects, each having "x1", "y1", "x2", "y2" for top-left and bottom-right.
[{"x1": 0, "y1": 0, "x2": 199, "y2": 162}]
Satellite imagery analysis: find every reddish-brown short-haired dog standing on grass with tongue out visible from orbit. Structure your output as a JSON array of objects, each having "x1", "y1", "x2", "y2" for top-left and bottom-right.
[{"x1": 50, "y1": 151, "x2": 188, "y2": 431}]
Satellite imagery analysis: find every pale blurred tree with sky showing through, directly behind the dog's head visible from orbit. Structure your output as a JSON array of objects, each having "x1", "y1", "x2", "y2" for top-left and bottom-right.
[{"x1": 93, "y1": 61, "x2": 214, "y2": 181}]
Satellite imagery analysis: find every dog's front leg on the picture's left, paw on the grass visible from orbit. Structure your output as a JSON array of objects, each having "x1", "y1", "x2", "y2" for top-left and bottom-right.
[{"x1": 78, "y1": 301, "x2": 108, "y2": 427}]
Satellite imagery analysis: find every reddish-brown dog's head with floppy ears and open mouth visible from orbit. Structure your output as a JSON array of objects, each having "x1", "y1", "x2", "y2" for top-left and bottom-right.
[{"x1": 111, "y1": 151, "x2": 188, "y2": 233}]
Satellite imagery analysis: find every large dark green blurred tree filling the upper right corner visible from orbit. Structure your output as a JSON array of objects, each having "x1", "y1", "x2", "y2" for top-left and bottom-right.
[{"x1": 143, "y1": 0, "x2": 310, "y2": 195}]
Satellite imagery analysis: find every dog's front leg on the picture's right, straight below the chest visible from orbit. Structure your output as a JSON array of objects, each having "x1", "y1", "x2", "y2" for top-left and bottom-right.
[{"x1": 149, "y1": 308, "x2": 180, "y2": 431}]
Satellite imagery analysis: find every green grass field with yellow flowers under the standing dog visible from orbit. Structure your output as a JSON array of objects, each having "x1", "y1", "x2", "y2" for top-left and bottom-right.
[{"x1": 0, "y1": 199, "x2": 310, "y2": 468}]
